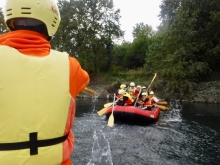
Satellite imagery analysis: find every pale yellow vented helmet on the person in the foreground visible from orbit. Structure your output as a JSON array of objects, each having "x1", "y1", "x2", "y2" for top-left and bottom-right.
[{"x1": 4, "y1": 0, "x2": 61, "y2": 37}]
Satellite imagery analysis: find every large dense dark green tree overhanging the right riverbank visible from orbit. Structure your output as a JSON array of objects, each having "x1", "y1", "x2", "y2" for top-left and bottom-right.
[{"x1": 139, "y1": 0, "x2": 220, "y2": 94}]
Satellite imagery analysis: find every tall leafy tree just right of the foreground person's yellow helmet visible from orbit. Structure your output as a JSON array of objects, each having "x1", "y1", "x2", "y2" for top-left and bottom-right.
[{"x1": 51, "y1": 0, "x2": 123, "y2": 73}]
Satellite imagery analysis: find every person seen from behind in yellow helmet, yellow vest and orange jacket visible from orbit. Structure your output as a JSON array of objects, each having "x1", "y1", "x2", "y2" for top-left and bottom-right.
[{"x1": 0, "y1": 0, "x2": 89, "y2": 165}]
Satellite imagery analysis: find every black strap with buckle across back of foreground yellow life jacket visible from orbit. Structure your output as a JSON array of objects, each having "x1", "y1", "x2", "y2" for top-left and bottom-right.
[{"x1": 0, "y1": 132, "x2": 69, "y2": 155}]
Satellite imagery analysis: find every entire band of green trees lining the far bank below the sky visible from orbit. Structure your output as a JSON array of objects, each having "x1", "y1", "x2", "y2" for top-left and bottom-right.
[{"x1": 0, "y1": 0, "x2": 220, "y2": 98}]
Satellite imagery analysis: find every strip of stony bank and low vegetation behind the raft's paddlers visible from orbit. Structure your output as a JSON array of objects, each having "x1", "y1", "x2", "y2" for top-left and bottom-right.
[{"x1": 77, "y1": 75, "x2": 220, "y2": 104}]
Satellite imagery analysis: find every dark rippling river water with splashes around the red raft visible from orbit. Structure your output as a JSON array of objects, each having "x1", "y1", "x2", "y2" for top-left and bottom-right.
[{"x1": 71, "y1": 98, "x2": 220, "y2": 165}]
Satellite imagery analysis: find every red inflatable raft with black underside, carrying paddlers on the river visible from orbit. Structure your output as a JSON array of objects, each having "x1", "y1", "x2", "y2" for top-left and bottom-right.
[{"x1": 106, "y1": 105, "x2": 160, "y2": 125}]
